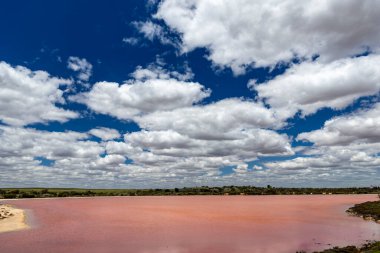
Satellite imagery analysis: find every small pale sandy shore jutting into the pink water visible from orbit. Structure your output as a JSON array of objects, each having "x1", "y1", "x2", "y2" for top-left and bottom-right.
[{"x1": 0, "y1": 205, "x2": 29, "y2": 233}]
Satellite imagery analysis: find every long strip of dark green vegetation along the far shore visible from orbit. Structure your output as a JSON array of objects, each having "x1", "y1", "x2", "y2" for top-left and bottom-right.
[{"x1": 0, "y1": 185, "x2": 380, "y2": 199}]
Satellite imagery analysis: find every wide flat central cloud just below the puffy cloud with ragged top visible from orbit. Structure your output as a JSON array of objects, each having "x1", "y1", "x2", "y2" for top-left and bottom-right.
[{"x1": 135, "y1": 98, "x2": 282, "y2": 140}]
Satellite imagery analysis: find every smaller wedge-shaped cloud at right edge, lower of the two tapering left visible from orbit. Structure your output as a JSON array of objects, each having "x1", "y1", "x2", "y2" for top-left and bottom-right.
[{"x1": 297, "y1": 103, "x2": 380, "y2": 146}]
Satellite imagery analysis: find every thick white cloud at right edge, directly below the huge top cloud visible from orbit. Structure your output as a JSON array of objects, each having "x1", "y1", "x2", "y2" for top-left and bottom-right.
[{"x1": 254, "y1": 55, "x2": 380, "y2": 118}]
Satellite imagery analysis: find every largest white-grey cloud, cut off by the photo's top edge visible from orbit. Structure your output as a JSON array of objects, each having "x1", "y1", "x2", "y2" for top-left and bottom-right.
[{"x1": 154, "y1": 0, "x2": 380, "y2": 74}]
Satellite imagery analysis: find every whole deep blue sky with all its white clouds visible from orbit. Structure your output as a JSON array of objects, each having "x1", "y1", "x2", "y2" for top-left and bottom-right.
[{"x1": 0, "y1": 0, "x2": 380, "y2": 188}]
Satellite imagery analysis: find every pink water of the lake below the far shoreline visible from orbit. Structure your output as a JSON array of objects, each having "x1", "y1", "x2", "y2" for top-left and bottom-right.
[{"x1": 0, "y1": 195, "x2": 380, "y2": 253}]
